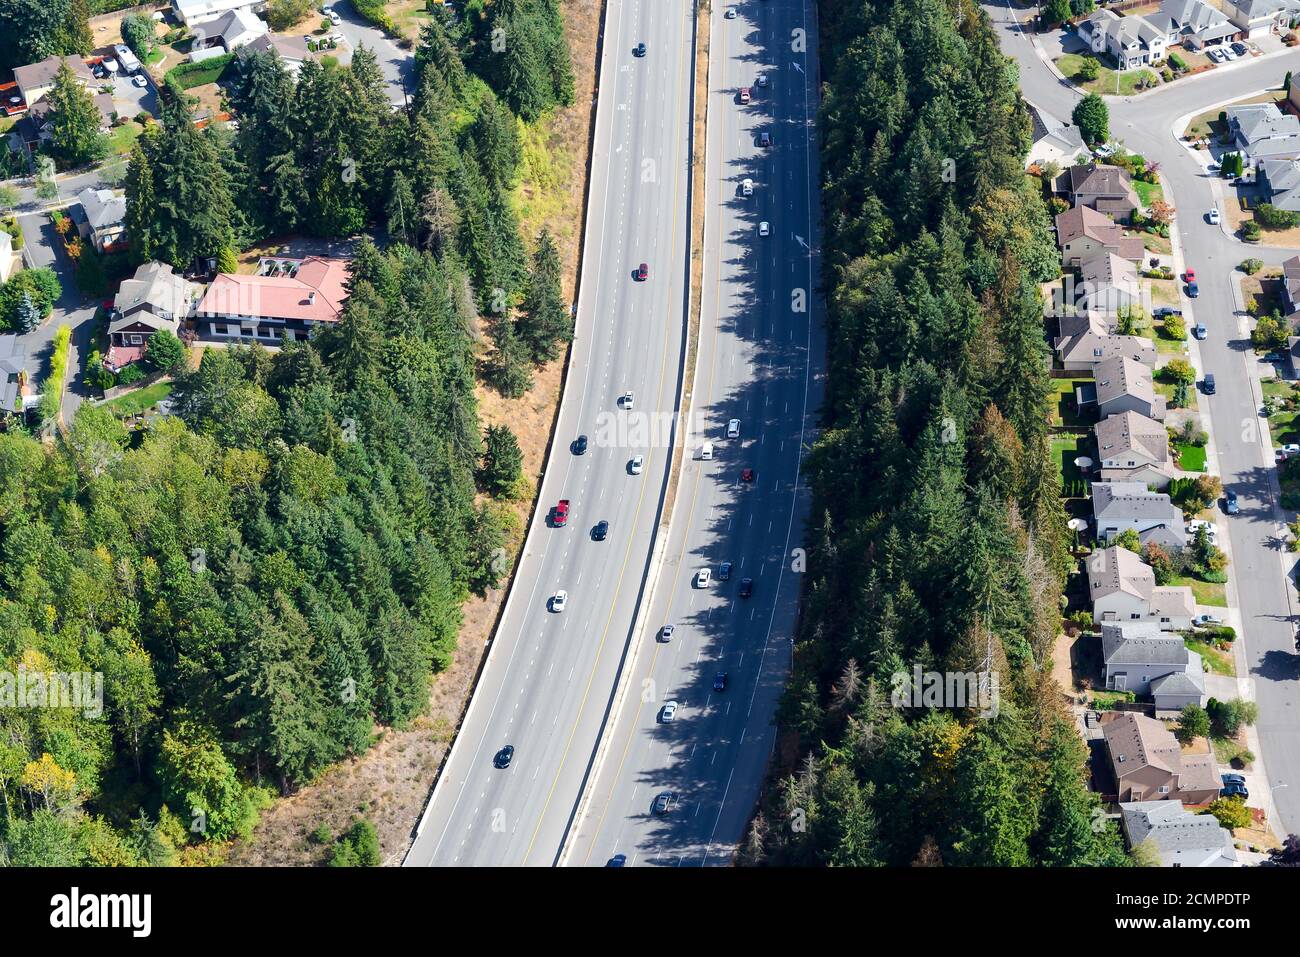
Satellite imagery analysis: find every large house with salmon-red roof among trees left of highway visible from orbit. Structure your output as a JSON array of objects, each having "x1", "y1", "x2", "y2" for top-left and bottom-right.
[{"x1": 195, "y1": 256, "x2": 347, "y2": 345}]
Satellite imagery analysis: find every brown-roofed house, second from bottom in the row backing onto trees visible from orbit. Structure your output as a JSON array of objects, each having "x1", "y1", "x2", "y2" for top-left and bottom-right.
[{"x1": 1101, "y1": 711, "x2": 1219, "y2": 806}]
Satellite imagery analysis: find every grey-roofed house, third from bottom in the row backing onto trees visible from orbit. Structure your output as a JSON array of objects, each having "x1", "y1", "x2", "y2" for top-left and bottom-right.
[{"x1": 1101, "y1": 622, "x2": 1206, "y2": 711}]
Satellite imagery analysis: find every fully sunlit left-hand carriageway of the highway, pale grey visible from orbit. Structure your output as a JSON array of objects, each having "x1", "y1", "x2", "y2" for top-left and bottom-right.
[{"x1": 404, "y1": 0, "x2": 694, "y2": 866}]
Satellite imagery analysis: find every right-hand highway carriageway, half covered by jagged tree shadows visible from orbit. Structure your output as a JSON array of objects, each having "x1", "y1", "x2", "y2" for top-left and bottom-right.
[{"x1": 563, "y1": 0, "x2": 826, "y2": 866}]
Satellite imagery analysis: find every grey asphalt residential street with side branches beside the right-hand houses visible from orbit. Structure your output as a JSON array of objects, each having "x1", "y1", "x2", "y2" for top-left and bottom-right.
[{"x1": 985, "y1": 3, "x2": 1300, "y2": 832}]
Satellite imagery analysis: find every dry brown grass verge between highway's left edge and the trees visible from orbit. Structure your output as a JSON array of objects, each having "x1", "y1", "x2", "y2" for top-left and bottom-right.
[{"x1": 228, "y1": 0, "x2": 605, "y2": 866}]
